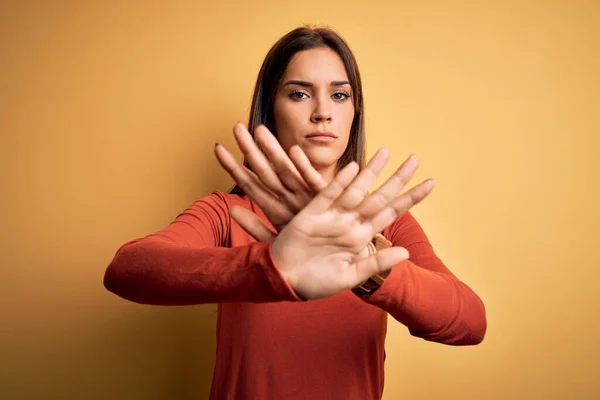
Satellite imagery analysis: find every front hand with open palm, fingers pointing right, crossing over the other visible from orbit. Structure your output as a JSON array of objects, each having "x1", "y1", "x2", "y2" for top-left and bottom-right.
[{"x1": 272, "y1": 156, "x2": 433, "y2": 300}]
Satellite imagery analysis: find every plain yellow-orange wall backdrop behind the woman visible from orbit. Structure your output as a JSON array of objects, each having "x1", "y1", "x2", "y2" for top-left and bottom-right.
[{"x1": 0, "y1": 0, "x2": 600, "y2": 400}]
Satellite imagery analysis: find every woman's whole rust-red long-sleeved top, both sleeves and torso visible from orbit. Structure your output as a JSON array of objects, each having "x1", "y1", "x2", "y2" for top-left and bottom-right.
[{"x1": 104, "y1": 192, "x2": 486, "y2": 400}]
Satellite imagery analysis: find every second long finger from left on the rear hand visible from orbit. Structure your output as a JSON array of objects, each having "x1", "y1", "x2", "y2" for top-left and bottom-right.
[{"x1": 233, "y1": 123, "x2": 287, "y2": 196}]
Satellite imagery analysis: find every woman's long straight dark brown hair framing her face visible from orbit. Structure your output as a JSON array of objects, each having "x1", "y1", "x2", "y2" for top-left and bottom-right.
[{"x1": 230, "y1": 27, "x2": 365, "y2": 195}]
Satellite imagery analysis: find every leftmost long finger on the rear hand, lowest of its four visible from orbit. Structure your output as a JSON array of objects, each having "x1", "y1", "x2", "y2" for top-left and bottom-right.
[{"x1": 215, "y1": 144, "x2": 293, "y2": 221}]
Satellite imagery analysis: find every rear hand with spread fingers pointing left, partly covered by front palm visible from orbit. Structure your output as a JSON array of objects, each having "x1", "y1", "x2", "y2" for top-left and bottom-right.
[{"x1": 215, "y1": 123, "x2": 327, "y2": 241}]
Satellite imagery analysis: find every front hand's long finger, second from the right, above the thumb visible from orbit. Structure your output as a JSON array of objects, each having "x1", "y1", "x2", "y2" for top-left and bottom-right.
[{"x1": 357, "y1": 155, "x2": 419, "y2": 219}]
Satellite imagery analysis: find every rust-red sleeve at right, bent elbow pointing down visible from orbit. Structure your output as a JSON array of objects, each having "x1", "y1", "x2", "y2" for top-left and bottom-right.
[{"x1": 360, "y1": 212, "x2": 487, "y2": 345}]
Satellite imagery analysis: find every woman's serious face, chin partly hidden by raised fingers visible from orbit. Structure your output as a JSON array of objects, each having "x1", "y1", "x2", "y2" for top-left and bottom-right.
[{"x1": 274, "y1": 48, "x2": 354, "y2": 172}]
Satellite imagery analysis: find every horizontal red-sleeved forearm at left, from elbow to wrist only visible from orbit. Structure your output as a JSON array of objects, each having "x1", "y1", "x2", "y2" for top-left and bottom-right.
[{"x1": 104, "y1": 239, "x2": 300, "y2": 305}]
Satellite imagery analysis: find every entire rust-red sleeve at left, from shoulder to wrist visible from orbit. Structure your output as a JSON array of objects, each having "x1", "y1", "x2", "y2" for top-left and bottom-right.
[{"x1": 104, "y1": 192, "x2": 302, "y2": 305}]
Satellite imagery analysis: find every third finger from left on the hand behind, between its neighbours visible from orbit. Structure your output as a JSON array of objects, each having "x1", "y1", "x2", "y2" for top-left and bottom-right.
[{"x1": 254, "y1": 125, "x2": 307, "y2": 195}]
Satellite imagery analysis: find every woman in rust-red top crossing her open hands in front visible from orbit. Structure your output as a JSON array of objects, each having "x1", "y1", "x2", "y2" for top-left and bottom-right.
[{"x1": 105, "y1": 28, "x2": 486, "y2": 400}]
